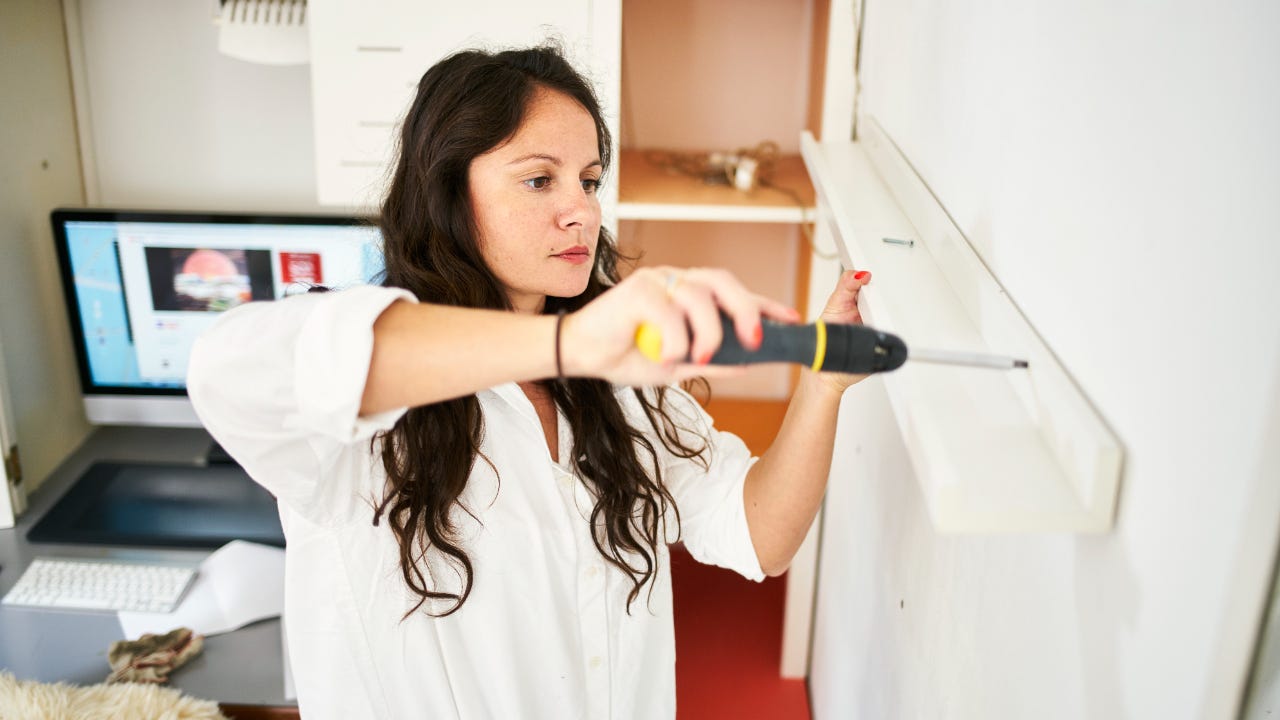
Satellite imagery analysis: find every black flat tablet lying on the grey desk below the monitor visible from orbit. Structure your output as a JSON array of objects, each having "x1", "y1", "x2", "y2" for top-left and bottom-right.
[{"x1": 27, "y1": 443, "x2": 284, "y2": 548}]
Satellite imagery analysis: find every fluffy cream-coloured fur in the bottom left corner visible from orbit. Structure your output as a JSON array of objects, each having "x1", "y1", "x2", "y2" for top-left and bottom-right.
[{"x1": 0, "y1": 673, "x2": 227, "y2": 720}]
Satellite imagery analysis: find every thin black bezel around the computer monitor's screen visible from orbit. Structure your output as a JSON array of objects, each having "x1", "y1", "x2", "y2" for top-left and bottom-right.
[{"x1": 49, "y1": 208, "x2": 378, "y2": 398}]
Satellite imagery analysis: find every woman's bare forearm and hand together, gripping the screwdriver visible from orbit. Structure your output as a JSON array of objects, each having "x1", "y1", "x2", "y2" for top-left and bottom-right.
[{"x1": 360, "y1": 268, "x2": 796, "y2": 415}]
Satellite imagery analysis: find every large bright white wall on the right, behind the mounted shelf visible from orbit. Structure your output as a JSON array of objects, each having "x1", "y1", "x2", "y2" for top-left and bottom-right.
[{"x1": 812, "y1": 0, "x2": 1280, "y2": 719}]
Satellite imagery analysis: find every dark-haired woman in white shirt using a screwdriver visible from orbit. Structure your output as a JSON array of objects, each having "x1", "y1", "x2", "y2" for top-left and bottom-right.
[{"x1": 188, "y1": 49, "x2": 864, "y2": 719}]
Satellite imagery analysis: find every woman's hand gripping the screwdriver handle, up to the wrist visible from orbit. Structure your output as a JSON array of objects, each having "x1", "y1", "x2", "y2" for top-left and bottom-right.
[{"x1": 559, "y1": 266, "x2": 800, "y2": 386}]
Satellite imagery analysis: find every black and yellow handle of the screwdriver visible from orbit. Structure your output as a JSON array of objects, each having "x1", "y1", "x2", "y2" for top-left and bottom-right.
[{"x1": 636, "y1": 313, "x2": 906, "y2": 374}]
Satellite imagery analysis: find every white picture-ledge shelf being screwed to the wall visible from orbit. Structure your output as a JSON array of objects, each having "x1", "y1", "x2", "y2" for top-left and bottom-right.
[{"x1": 801, "y1": 117, "x2": 1123, "y2": 533}]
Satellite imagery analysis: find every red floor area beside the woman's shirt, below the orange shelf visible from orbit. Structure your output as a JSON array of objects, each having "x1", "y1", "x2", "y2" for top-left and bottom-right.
[{"x1": 671, "y1": 546, "x2": 809, "y2": 720}]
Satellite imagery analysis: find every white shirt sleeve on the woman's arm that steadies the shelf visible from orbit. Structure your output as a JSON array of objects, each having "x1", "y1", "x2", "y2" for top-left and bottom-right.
[{"x1": 634, "y1": 388, "x2": 764, "y2": 582}]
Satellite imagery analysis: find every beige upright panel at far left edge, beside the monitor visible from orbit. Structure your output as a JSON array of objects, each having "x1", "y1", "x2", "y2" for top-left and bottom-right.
[{"x1": 0, "y1": 0, "x2": 88, "y2": 491}]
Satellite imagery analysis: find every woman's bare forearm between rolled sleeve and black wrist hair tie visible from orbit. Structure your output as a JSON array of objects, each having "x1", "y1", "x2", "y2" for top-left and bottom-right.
[{"x1": 360, "y1": 301, "x2": 556, "y2": 415}]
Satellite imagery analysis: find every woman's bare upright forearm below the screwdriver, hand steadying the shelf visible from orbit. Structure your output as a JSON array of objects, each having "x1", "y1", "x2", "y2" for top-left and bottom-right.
[{"x1": 744, "y1": 370, "x2": 841, "y2": 575}]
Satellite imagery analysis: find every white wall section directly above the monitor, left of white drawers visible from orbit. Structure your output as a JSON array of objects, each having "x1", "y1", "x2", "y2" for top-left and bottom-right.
[{"x1": 67, "y1": 0, "x2": 322, "y2": 213}]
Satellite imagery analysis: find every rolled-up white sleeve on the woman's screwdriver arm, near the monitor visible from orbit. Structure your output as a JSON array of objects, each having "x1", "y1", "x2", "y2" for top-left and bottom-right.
[{"x1": 187, "y1": 286, "x2": 415, "y2": 521}]
